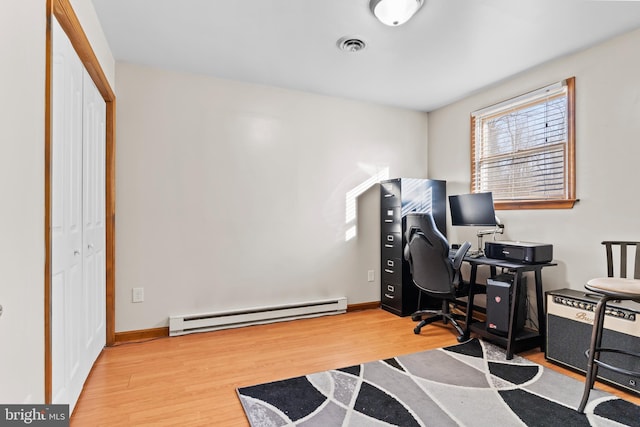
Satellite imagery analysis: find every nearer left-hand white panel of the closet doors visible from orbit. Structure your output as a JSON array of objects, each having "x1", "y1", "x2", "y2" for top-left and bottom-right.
[{"x1": 51, "y1": 18, "x2": 84, "y2": 410}]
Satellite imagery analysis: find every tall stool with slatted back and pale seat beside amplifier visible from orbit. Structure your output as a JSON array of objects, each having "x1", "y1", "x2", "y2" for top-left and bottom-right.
[{"x1": 578, "y1": 241, "x2": 640, "y2": 412}]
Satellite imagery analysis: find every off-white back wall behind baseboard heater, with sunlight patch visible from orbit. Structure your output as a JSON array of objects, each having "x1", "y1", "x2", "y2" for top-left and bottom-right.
[{"x1": 116, "y1": 63, "x2": 427, "y2": 331}]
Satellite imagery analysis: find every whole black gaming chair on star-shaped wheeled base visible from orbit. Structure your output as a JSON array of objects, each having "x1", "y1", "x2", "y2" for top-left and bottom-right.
[{"x1": 404, "y1": 213, "x2": 471, "y2": 342}]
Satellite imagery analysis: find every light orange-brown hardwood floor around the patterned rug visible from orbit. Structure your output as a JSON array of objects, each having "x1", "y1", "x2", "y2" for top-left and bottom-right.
[{"x1": 71, "y1": 309, "x2": 640, "y2": 427}]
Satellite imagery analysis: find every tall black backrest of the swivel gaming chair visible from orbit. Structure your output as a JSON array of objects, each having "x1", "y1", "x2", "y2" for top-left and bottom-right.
[{"x1": 405, "y1": 213, "x2": 464, "y2": 298}]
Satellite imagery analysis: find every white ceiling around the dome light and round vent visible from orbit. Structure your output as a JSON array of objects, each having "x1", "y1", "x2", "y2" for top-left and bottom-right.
[{"x1": 92, "y1": 0, "x2": 640, "y2": 111}]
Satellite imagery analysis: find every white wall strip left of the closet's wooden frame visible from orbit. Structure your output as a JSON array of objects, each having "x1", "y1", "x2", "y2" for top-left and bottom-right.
[{"x1": 0, "y1": 0, "x2": 113, "y2": 403}]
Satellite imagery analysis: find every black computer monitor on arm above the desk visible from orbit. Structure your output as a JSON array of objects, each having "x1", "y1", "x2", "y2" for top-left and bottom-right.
[{"x1": 449, "y1": 192, "x2": 496, "y2": 227}]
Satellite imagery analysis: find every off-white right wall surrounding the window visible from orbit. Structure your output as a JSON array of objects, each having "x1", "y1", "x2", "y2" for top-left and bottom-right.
[{"x1": 428, "y1": 26, "x2": 640, "y2": 289}]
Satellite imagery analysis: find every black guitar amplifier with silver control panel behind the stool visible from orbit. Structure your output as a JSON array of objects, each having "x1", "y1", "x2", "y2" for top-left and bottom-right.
[{"x1": 545, "y1": 289, "x2": 640, "y2": 393}]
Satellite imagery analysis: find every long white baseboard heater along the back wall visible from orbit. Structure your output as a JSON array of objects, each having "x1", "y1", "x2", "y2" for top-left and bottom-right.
[{"x1": 169, "y1": 297, "x2": 347, "y2": 337}]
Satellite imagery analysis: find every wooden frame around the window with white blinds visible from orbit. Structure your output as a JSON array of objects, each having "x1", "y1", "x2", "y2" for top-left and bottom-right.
[{"x1": 470, "y1": 77, "x2": 578, "y2": 210}]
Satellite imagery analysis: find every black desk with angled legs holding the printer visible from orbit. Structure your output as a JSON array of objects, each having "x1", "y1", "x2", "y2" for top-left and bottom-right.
[{"x1": 464, "y1": 257, "x2": 557, "y2": 360}]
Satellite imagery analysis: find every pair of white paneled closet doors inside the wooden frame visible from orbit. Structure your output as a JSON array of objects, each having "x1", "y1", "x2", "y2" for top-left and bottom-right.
[{"x1": 50, "y1": 20, "x2": 106, "y2": 411}]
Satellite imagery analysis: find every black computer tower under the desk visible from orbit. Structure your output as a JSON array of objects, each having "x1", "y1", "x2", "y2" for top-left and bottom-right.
[{"x1": 486, "y1": 274, "x2": 527, "y2": 337}]
